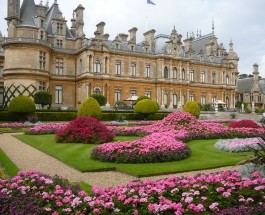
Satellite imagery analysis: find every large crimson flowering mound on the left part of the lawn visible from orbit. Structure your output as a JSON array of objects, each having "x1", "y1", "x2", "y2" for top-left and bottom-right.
[{"x1": 55, "y1": 116, "x2": 114, "y2": 144}]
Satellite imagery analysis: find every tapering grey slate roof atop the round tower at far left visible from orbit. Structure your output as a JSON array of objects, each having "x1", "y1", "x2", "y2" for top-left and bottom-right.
[{"x1": 19, "y1": 0, "x2": 37, "y2": 27}]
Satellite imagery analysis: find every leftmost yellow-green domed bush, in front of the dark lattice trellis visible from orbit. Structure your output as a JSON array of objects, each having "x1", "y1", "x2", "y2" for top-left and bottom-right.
[{"x1": 8, "y1": 96, "x2": 36, "y2": 113}]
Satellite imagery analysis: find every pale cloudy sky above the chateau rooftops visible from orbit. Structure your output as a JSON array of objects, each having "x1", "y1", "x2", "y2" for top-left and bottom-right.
[{"x1": 0, "y1": 0, "x2": 265, "y2": 78}]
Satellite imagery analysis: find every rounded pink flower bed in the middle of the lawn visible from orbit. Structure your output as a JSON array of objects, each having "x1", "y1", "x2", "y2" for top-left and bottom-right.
[{"x1": 91, "y1": 131, "x2": 191, "y2": 163}]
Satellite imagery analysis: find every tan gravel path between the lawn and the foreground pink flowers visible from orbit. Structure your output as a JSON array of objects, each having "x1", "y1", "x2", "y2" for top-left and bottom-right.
[{"x1": 0, "y1": 134, "x2": 239, "y2": 187}]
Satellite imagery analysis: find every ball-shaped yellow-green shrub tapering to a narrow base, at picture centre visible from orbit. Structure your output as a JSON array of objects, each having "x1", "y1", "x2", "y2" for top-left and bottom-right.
[{"x1": 134, "y1": 99, "x2": 158, "y2": 119}]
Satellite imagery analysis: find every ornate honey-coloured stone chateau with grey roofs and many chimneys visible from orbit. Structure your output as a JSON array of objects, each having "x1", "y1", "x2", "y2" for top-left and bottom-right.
[{"x1": 0, "y1": 0, "x2": 239, "y2": 108}]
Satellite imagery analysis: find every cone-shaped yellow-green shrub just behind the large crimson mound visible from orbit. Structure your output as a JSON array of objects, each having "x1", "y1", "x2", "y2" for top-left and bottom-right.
[{"x1": 77, "y1": 97, "x2": 102, "y2": 119}]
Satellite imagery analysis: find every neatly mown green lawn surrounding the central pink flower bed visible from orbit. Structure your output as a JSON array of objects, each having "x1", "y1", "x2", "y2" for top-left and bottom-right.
[{"x1": 15, "y1": 135, "x2": 251, "y2": 177}]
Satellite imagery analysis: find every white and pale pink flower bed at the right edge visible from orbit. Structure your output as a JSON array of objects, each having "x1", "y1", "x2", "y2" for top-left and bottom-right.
[{"x1": 214, "y1": 138, "x2": 264, "y2": 152}]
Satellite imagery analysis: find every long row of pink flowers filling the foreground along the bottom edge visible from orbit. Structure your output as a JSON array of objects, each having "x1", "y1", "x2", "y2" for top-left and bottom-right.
[{"x1": 0, "y1": 171, "x2": 265, "y2": 215}]
